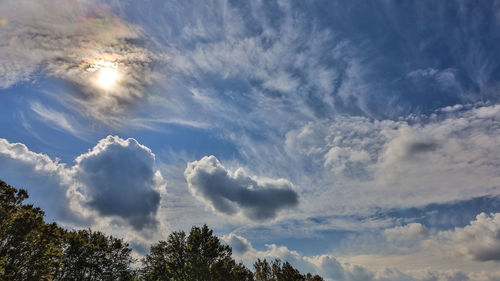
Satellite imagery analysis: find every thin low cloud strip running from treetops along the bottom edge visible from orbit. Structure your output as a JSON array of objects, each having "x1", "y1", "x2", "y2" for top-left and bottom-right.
[{"x1": 221, "y1": 233, "x2": 498, "y2": 281}]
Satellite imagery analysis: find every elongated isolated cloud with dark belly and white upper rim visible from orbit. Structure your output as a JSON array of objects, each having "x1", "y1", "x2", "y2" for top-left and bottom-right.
[{"x1": 184, "y1": 156, "x2": 298, "y2": 220}]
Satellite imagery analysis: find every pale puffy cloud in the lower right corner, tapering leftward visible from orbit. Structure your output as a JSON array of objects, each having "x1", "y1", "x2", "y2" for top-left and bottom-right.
[{"x1": 339, "y1": 213, "x2": 500, "y2": 280}]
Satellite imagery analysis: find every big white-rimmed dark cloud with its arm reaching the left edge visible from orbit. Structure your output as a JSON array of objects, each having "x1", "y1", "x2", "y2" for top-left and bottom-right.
[{"x1": 0, "y1": 136, "x2": 165, "y2": 230}]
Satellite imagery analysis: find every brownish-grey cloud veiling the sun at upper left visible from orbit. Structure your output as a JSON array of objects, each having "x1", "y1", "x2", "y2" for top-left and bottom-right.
[{"x1": 0, "y1": 0, "x2": 157, "y2": 124}]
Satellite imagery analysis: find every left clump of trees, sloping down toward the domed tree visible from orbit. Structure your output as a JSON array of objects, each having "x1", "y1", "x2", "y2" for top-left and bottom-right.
[{"x1": 0, "y1": 180, "x2": 134, "y2": 281}]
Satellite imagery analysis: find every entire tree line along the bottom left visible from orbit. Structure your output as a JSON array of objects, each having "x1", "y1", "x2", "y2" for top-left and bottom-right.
[{"x1": 0, "y1": 180, "x2": 323, "y2": 281}]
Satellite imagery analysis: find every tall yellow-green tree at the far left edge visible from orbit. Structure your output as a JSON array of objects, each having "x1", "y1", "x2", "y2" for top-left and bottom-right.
[{"x1": 0, "y1": 180, "x2": 62, "y2": 280}]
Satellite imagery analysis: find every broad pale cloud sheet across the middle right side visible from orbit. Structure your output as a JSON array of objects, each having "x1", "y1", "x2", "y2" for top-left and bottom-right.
[{"x1": 278, "y1": 105, "x2": 500, "y2": 219}]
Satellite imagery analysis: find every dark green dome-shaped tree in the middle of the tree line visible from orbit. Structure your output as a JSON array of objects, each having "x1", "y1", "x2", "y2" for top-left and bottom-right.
[{"x1": 142, "y1": 225, "x2": 253, "y2": 281}]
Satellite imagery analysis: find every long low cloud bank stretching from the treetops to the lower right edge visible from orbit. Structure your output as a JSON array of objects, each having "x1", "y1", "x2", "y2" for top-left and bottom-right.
[{"x1": 221, "y1": 213, "x2": 500, "y2": 281}]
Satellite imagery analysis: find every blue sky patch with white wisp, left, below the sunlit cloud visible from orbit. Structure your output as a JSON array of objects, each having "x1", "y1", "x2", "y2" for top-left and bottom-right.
[{"x1": 0, "y1": 78, "x2": 92, "y2": 163}]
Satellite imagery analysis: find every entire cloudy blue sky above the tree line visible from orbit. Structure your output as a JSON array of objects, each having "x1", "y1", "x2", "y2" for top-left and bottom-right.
[{"x1": 0, "y1": 0, "x2": 500, "y2": 281}]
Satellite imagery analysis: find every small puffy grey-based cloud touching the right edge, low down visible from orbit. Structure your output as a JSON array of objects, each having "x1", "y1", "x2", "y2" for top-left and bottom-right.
[{"x1": 445, "y1": 213, "x2": 500, "y2": 261}]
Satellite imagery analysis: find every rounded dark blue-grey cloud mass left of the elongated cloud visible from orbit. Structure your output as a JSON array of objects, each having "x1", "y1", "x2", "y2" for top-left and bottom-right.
[{"x1": 74, "y1": 136, "x2": 160, "y2": 229}]
